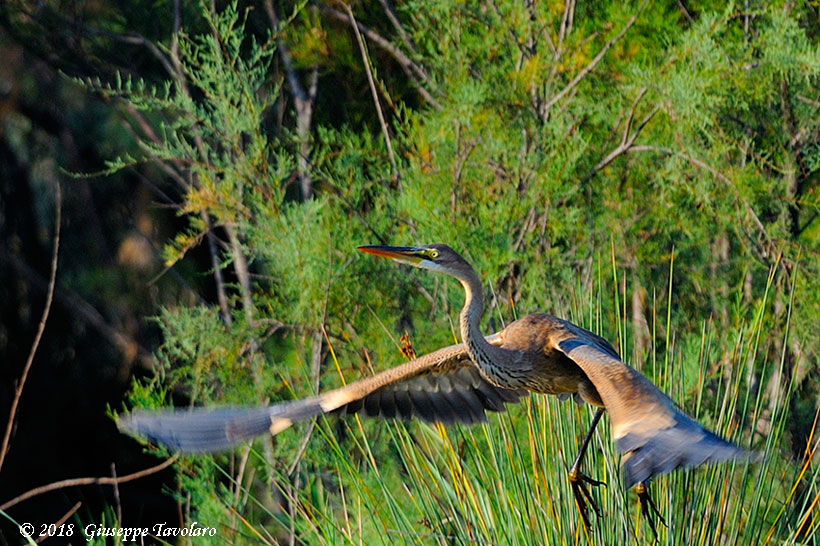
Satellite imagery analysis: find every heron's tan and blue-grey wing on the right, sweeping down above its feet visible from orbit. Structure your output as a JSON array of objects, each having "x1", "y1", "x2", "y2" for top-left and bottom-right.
[{"x1": 554, "y1": 323, "x2": 750, "y2": 488}]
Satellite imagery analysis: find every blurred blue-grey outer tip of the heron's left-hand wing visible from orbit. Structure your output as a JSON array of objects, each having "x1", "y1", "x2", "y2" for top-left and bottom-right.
[{"x1": 118, "y1": 396, "x2": 324, "y2": 453}]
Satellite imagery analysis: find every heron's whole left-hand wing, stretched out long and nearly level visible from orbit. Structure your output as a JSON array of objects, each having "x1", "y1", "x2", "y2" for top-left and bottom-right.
[{"x1": 119, "y1": 334, "x2": 526, "y2": 452}]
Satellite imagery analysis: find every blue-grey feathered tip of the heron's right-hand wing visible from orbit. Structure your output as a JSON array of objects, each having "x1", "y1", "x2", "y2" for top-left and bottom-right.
[{"x1": 617, "y1": 412, "x2": 757, "y2": 488}]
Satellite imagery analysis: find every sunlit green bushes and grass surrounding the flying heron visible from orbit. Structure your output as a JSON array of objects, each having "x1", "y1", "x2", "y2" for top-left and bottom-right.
[{"x1": 104, "y1": 0, "x2": 820, "y2": 544}]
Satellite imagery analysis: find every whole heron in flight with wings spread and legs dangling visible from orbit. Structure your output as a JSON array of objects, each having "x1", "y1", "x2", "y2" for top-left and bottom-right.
[{"x1": 120, "y1": 244, "x2": 748, "y2": 532}]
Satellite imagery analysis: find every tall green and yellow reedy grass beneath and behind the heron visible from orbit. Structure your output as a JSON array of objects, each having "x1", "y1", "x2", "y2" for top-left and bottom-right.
[{"x1": 223, "y1": 258, "x2": 820, "y2": 546}]
